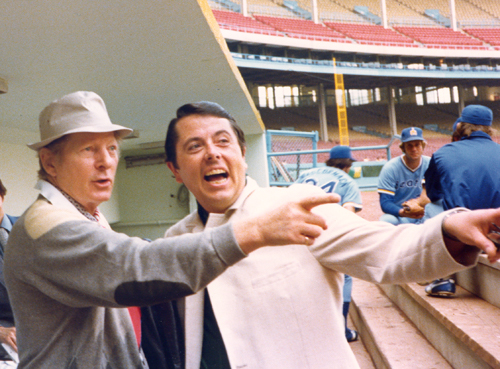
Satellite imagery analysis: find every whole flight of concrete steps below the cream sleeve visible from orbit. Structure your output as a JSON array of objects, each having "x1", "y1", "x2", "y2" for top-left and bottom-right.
[{"x1": 350, "y1": 257, "x2": 500, "y2": 369}]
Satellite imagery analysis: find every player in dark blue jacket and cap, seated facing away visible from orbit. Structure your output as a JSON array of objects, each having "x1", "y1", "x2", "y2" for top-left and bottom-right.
[{"x1": 423, "y1": 105, "x2": 500, "y2": 296}]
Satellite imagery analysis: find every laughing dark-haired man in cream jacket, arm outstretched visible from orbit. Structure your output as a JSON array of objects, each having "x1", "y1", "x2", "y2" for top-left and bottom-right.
[{"x1": 165, "y1": 102, "x2": 500, "y2": 369}]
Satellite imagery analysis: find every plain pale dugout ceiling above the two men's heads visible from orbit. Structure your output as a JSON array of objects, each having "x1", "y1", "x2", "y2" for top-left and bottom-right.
[{"x1": 0, "y1": 0, "x2": 263, "y2": 149}]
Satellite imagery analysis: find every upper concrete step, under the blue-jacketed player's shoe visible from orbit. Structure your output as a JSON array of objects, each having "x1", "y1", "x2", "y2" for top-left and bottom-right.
[{"x1": 380, "y1": 283, "x2": 500, "y2": 369}]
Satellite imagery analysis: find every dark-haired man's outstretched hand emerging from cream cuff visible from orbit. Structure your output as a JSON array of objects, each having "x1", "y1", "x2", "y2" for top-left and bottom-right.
[{"x1": 442, "y1": 209, "x2": 500, "y2": 264}]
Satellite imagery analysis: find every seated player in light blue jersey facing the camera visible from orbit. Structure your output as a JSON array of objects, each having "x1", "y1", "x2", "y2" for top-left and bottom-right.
[{"x1": 378, "y1": 127, "x2": 430, "y2": 225}]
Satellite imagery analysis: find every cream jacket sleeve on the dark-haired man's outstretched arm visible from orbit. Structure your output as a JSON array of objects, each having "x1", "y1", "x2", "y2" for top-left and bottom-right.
[{"x1": 311, "y1": 205, "x2": 479, "y2": 283}]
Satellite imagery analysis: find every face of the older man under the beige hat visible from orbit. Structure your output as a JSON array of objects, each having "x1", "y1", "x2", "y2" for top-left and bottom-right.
[{"x1": 40, "y1": 132, "x2": 119, "y2": 214}]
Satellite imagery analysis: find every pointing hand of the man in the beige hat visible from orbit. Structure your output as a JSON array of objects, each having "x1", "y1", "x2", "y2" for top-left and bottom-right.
[{"x1": 233, "y1": 193, "x2": 340, "y2": 254}]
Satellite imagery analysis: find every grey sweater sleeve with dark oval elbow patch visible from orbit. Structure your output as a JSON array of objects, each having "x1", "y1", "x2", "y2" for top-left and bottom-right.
[{"x1": 11, "y1": 220, "x2": 245, "y2": 307}]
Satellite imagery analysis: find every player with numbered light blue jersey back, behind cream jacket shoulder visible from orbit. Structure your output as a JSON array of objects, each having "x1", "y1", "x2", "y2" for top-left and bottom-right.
[{"x1": 296, "y1": 145, "x2": 363, "y2": 342}]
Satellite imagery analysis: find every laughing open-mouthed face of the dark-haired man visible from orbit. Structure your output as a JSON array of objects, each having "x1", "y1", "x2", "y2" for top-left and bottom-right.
[{"x1": 167, "y1": 115, "x2": 247, "y2": 213}]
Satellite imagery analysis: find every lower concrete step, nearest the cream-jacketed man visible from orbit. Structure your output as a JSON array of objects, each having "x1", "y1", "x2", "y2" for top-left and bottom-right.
[{"x1": 349, "y1": 279, "x2": 454, "y2": 369}]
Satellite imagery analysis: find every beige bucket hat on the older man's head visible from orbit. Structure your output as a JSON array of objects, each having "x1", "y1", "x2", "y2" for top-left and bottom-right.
[{"x1": 28, "y1": 91, "x2": 133, "y2": 150}]
